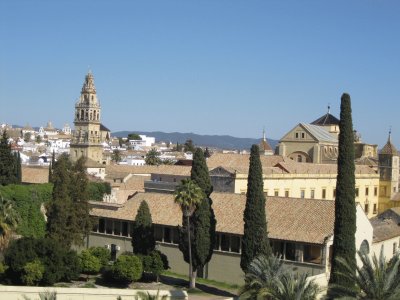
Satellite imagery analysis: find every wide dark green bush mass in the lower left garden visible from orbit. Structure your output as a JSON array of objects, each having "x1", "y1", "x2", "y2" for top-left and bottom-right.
[{"x1": 4, "y1": 238, "x2": 80, "y2": 285}]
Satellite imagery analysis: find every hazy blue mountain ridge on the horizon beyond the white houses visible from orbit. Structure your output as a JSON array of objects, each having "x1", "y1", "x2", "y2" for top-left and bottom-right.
[{"x1": 112, "y1": 131, "x2": 278, "y2": 150}]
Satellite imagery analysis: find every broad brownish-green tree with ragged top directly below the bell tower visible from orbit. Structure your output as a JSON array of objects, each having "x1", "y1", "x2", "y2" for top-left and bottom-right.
[{"x1": 47, "y1": 154, "x2": 92, "y2": 248}]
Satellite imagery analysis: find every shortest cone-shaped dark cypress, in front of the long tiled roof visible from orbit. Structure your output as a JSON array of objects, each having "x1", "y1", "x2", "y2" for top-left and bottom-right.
[{"x1": 132, "y1": 200, "x2": 156, "y2": 255}]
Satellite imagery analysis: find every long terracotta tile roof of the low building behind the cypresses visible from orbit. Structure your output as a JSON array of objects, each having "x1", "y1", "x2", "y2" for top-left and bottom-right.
[{"x1": 91, "y1": 193, "x2": 335, "y2": 244}]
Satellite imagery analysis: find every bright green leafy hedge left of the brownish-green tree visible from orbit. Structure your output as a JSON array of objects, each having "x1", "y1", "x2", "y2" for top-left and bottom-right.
[{"x1": 0, "y1": 183, "x2": 52, "y2": 238}]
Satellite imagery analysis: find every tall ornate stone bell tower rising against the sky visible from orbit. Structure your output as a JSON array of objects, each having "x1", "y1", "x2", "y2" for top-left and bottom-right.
[{"x1": 70, "y1": 71, "x2": 104, "y2": 163}]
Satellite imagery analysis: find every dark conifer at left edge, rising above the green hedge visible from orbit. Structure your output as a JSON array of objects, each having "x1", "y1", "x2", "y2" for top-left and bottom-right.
[{"x1": 0, "y1": 130, "x2": 18, "y2": 185}]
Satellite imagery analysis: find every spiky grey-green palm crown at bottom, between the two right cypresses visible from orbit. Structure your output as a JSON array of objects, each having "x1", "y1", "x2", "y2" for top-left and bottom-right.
[{"x1": 239, "y1": 255, "x2": 319, "y2": 300}]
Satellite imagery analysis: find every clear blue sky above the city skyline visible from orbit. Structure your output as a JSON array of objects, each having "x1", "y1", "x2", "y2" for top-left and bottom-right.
[{"x1": 0, "y1": 0, "x2": 400, "y2": 148}]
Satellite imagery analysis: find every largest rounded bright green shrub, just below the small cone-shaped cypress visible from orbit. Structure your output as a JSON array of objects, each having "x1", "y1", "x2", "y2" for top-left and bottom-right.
[{"x1": 112, "y1": 255, "x2": 143, "y2": 282}]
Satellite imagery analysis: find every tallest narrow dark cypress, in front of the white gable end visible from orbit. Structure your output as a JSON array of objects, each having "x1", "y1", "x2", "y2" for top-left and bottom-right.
[{"x1": 328, "y1": 94, "x2": 356, "y2": 295}]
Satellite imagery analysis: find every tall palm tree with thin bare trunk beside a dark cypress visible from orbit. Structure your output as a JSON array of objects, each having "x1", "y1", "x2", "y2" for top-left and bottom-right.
[{"x1": 175, "y1": 179, "x2": 205, "y2": 288}]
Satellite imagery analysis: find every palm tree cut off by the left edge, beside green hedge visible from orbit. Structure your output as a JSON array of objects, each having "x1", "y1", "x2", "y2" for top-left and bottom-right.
[{"x1": 0, "y1": 196, "x2": 18, "y2": 253}]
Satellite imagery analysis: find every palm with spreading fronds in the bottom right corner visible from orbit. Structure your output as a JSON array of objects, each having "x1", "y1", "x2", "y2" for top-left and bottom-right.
[{"x1": 332, "y1": 245, "x2": 400, "y2": 300}]
